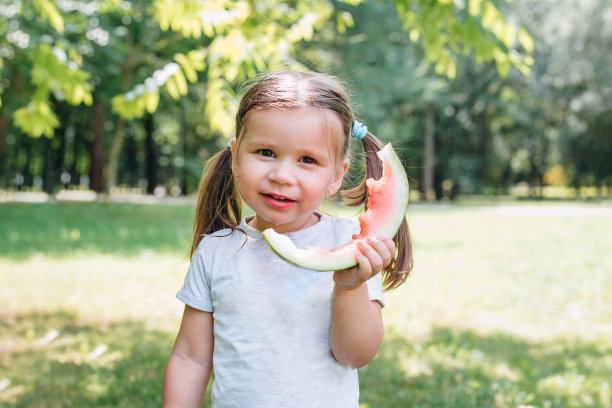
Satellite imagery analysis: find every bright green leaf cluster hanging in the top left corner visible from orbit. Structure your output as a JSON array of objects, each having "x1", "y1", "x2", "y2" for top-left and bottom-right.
[{"x1": 0, "y1": 0, "x2": 92, "y2": 137}]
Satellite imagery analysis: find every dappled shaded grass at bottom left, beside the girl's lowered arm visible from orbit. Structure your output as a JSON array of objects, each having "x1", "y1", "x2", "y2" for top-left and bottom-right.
[{"x1": 0, "y1": 312, "x2": 210, "y2": 408}]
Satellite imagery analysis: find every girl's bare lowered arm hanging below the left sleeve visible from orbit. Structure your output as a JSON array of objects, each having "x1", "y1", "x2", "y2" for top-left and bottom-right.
[{"x1": 162, "y1": 306, "x2": 214, "y2": 408}]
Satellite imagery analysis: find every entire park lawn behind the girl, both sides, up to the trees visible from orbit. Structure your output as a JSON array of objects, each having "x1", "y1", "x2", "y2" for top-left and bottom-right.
[{"x1": 0, "y1": 203, "x2": 612, "y2": 408}]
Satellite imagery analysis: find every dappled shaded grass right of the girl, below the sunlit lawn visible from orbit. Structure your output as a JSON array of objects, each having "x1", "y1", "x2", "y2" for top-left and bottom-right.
[{"x1": 360, "y1": 328, "x2": 612, "y2": 408}]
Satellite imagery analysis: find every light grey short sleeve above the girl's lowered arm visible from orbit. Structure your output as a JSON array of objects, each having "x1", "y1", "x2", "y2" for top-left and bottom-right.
[{"x1": 176, "y1": 245, "x2": 213, "y2": 312}]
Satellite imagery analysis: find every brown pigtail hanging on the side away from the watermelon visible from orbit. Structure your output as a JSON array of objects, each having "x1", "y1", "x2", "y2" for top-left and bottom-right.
[{"x1": 189, "y1": 148, "x2": 242, "y2": 258}]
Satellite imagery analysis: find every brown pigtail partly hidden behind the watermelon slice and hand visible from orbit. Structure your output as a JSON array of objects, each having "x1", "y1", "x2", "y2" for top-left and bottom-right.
[{"x1": 341, "y1": 132, "x2": 413, "y2": 290}]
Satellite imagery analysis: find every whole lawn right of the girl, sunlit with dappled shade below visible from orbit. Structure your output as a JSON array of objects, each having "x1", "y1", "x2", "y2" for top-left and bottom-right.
[{"x1": 362, "y1": 207, "x2": 612, "y2": 408}]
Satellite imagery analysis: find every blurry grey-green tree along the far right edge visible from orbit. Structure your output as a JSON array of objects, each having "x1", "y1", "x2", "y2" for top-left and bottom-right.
[{"x1": 500, "y1": 0, "x2": 612, "y2": 195}]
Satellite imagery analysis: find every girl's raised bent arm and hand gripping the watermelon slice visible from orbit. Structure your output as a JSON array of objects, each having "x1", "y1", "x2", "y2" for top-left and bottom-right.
[{"x1": 329, "y1": 238, "x2": 395, "y2": 368}]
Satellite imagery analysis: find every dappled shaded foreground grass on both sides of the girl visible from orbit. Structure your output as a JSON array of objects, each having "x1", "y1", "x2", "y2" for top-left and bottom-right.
[{"x1": 0, "y1": 312, "x2": 612, "y2": 408}]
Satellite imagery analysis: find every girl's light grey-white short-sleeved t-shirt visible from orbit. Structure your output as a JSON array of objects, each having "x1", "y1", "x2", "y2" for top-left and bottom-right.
[{"x1": 177, "y1": 214, "x2": 383, "y2": 408}]
